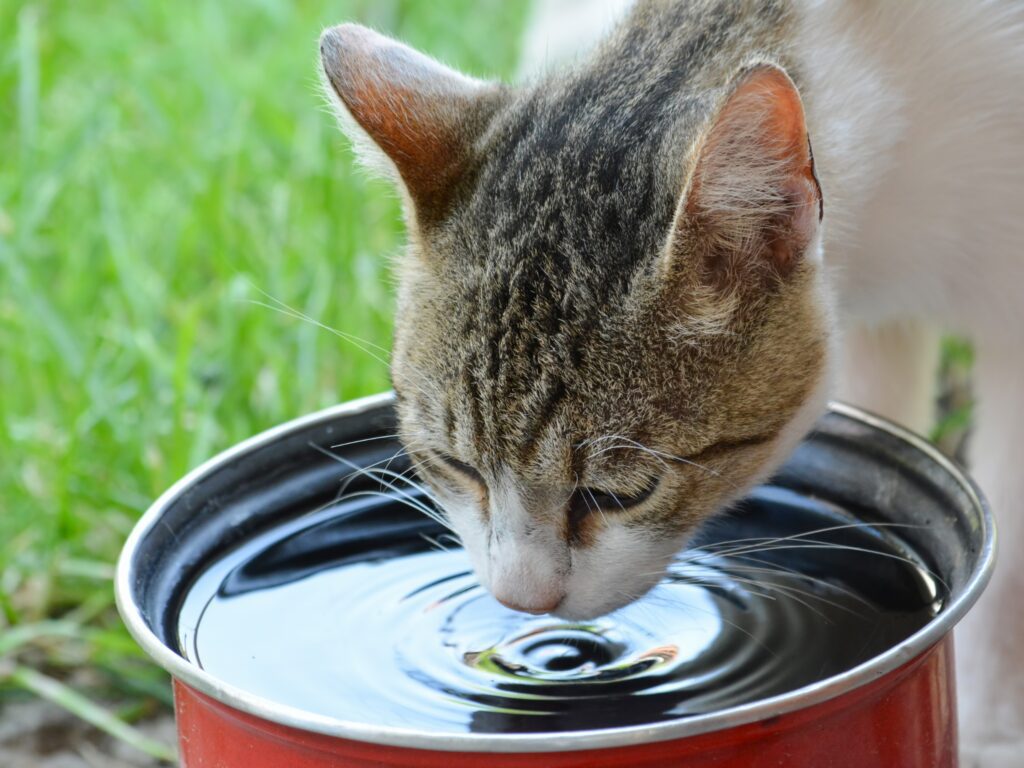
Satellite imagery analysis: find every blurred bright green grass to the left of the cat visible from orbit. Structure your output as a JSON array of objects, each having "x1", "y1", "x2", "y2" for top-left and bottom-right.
[{"x1": 0, "y1": 0, "x2": 524, "y2": 756}]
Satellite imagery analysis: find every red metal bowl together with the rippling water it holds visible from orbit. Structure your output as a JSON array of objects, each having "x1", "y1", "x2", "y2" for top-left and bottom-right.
[{"x1": 116, "y1": 393, "x2": 995, "y2": 768}]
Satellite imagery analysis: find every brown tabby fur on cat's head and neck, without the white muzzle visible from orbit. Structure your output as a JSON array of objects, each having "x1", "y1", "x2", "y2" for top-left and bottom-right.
[{"x1": 322, "y1": 0, "x2": 828, "y2": 614}]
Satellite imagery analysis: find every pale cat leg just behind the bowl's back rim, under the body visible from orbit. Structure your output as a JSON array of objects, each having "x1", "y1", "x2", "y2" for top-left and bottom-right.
[{"x1": 838, "y1": 323, "x2": 939, "y2": 435}]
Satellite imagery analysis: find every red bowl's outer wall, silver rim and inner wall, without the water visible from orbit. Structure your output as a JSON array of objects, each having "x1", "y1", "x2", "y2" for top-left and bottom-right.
[{"x1": 117, "y1": 395, "x2": 995, "y2": 768}]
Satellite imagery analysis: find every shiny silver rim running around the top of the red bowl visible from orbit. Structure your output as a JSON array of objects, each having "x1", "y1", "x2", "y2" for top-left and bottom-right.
[{"x1": 115, "y1": 392, "x2": 995, "y2": 753}]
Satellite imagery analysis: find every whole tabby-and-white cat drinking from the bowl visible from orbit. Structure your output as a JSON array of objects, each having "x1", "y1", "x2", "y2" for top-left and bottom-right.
[{"x1": 321, "y1": 0, "x2": 1024, "y2": 768}]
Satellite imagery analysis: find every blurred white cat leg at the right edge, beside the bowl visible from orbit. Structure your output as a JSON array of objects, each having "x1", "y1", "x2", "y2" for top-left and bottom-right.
[{"x1": 955, "y1": 337, "x2": 1024, "y2": 768}]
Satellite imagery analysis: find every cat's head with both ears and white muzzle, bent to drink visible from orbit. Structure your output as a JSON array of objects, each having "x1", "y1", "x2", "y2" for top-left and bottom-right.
[{"x1": 322, "y1": 25, "x2": 830, "y2": 618}]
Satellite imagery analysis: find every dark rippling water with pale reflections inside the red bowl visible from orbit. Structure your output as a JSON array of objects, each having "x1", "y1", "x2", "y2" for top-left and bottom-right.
[{"x1": 178, "y1": 487, "x2": 942, "y2": 732}]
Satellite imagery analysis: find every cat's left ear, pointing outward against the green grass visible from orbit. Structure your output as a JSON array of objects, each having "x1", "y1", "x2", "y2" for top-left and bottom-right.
[{"x1": 321, "y1": 24, "x2": 501, "y2": 227}]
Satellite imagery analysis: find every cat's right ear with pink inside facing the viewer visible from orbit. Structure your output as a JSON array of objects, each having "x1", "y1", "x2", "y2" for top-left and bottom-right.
[{"x1": 668, "y1": 65, "x2": 823, "y2": 287}]
